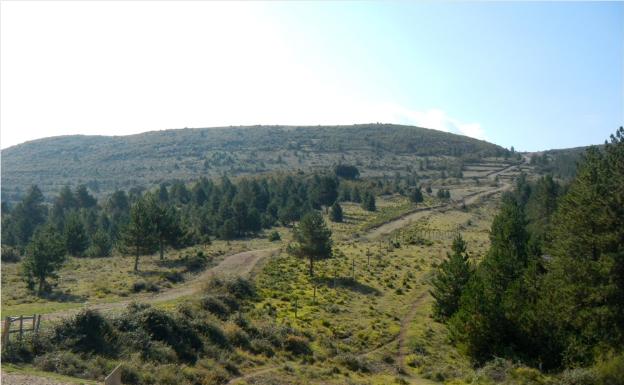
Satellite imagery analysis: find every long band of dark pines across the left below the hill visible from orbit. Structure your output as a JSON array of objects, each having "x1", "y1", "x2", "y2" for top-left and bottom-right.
[{"x1": 2, "y1": 174, "x2": 375, "y2": 293}]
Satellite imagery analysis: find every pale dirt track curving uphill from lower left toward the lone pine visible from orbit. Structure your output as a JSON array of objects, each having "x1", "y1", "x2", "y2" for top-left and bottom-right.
[{"x1": 43, "y1": 248, "x2": 279, "y2": 321}]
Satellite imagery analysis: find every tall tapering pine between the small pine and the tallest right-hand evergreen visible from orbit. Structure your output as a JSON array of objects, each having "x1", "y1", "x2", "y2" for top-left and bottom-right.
[{"x1": 449, "y1": 195, "x2": 529, "y2": 362}]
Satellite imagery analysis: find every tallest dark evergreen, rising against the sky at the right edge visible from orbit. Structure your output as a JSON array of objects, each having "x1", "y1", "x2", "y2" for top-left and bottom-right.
[{"x1": 540, "y1": 127, "x2": 624, "y2": 365}]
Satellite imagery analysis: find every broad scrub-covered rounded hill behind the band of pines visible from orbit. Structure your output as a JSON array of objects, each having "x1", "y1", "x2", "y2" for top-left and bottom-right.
[{"x1": 2, "y1": 124, "x2": 506, "y2": 201}]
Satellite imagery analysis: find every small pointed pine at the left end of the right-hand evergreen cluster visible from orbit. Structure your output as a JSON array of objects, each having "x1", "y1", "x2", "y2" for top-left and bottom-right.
[{"x1": 430, "y1": 235, "x2": 472, "y2": 321}]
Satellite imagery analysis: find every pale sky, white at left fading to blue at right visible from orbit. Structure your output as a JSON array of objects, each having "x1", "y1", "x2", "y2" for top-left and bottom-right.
[{"x1": 0, "y1": 1, "x2": 624, "y2": 151}]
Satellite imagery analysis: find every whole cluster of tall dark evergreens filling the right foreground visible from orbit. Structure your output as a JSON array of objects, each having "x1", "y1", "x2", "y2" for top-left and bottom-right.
[{"x1": 432, "y1": 127, "x2": 624, "y2": 370}]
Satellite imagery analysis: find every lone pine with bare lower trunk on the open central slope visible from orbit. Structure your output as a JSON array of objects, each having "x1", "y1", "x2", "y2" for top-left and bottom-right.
[{"x1": 291, "y1": 211, "x2": 332, "y2": 277}]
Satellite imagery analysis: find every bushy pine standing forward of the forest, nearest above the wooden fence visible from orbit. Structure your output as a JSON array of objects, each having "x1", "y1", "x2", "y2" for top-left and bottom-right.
[{"x1": 22, "y1": 225, "x2": 65, "y2": 294}]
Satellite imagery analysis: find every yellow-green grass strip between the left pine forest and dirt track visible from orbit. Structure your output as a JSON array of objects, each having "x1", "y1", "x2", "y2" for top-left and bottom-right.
[{"x1": 2, "y1": 236, "x2": 284, "y2": 316}]
